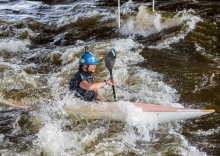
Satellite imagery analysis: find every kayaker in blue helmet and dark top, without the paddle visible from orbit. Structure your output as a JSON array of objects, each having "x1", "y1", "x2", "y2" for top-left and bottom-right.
[{"x1": 69, "y1": 47, "x2": 115, "y2": 101}]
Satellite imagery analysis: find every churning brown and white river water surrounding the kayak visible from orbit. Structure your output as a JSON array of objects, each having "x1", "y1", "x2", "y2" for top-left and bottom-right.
[{"x1": 0, "y1": 0, "x2": 220, "y2": 156}]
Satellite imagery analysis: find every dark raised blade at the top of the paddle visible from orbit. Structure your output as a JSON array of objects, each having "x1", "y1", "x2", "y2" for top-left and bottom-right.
[{"x1": 105, "y1": 49, "x2": 116, "y2": 73}]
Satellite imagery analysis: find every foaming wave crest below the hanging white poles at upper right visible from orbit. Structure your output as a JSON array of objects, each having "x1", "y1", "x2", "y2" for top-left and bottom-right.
[{"x1": 120, "y1": 6, "x2": 202, "y2": 49}]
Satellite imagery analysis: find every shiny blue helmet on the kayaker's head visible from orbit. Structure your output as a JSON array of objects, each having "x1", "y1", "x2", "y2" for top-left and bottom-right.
[{"x1": 79, "y1": 51, "x2": 99, "y2": 65}]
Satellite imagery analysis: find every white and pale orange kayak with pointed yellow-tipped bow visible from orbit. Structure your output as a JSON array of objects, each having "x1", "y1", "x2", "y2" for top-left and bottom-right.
[{"x1": 65, "y1": 102, "x2": 215, "y2": 123}]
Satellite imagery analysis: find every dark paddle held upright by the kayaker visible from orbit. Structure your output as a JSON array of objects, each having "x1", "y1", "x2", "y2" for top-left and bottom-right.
[{"x1": 105, "y1": 49, "x2": 116, "y2": 101}]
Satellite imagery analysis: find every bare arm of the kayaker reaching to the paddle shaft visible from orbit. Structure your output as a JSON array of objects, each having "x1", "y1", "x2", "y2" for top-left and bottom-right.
[{"x1": 79, "y1": 79, "x2": 115, "y2": 91}]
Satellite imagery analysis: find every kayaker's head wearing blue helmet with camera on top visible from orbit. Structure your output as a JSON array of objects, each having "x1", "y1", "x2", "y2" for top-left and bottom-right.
[{"x1": 79, "y1": 47, "x2": 99, "y2": 73}]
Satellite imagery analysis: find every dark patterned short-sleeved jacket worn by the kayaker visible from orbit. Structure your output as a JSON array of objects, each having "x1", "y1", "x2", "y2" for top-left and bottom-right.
[{"x1": 69, "y1": 70, "x2": 98, "y2": 101}]
